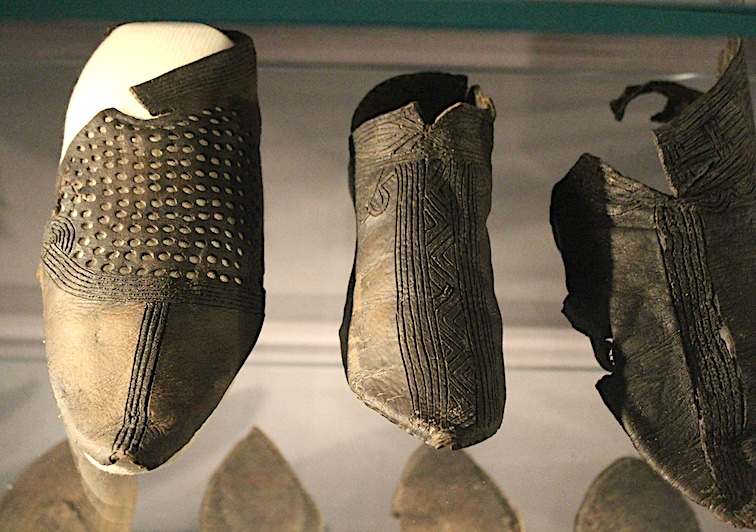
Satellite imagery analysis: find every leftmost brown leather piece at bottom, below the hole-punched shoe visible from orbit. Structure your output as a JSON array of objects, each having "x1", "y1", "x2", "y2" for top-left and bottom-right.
[{"x1": 0, "y1": 441, "x2": 136, "y2": 532}]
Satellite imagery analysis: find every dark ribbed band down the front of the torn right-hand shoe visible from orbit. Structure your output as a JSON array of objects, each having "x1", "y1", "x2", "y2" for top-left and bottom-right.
[{"x1": 656, "y1": 203, "x2": 754, "y2": 509}]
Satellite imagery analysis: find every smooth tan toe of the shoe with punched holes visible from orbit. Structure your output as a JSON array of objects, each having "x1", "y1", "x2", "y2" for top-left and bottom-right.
[{"x1": 42, "y1": 274, "x2": 262, "y2": 473}]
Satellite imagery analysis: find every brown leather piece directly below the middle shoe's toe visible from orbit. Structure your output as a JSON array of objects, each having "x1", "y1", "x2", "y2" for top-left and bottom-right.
[{"x1": 392, "y1": 445, "x2": 522, "y2": 532}]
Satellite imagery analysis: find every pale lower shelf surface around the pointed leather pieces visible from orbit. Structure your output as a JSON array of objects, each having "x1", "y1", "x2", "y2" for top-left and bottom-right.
[{"x1": 0, "y1": 353, "x2": 734, "y2": 532}]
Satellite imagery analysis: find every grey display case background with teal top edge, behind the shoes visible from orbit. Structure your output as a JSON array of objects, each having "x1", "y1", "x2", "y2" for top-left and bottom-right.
[{"x1": 0, "y1": 0, "x2": 756, "y2": 531}]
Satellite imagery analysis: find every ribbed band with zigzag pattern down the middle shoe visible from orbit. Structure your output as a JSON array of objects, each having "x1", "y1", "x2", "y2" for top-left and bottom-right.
[{"x1": 395, "y1": 159, "x2": 501, "y2": 429}]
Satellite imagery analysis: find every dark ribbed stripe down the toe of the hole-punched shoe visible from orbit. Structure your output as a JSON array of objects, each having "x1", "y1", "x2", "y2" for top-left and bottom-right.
[{"x1": 113, "y1": 303, "x2": 168, "y2": 456}]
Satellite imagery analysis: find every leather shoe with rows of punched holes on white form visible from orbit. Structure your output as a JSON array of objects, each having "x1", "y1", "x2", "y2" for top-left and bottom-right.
[{"x1": 39, "y1": 23, "x2": 264, "y2": 473}]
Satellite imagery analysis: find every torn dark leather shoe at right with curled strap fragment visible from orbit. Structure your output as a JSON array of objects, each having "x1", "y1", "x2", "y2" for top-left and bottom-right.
[{"x1": 551, "y1": 41, "x2": 756, "y2": 527}]
